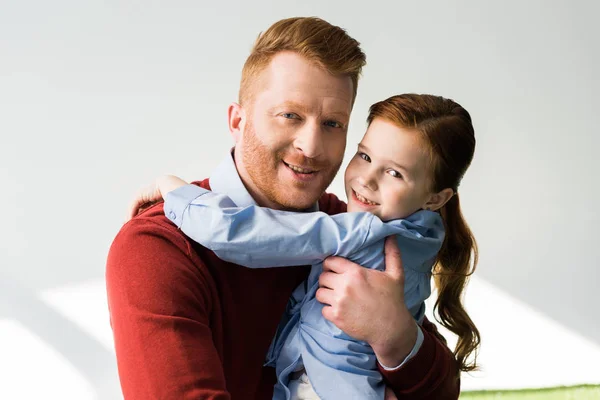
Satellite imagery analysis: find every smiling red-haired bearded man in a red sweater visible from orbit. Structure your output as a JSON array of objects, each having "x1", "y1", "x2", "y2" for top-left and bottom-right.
[{"x1": 107, "y1": 18, "x2": 459, "y2": 400}]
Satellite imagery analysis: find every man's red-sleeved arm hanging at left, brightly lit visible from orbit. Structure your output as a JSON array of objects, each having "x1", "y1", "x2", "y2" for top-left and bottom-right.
[{"x1": 106, "y1": 211, "x2": 230, "y2": 400}]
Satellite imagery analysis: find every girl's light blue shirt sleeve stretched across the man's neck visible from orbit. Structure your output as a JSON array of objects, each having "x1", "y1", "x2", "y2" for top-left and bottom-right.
[{"x1": 165, "y1": 185, "x2": 374, "y2": 268}]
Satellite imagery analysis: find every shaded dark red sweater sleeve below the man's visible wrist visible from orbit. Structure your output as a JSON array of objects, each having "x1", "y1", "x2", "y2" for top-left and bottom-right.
[{"x1": 378, "y1": 318, "x2": 460, "y2": 400}]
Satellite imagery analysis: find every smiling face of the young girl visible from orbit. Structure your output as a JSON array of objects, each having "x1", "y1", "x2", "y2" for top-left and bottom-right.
[{"x1": 344, "y1": 118, "x2": 435, "y2": 221}]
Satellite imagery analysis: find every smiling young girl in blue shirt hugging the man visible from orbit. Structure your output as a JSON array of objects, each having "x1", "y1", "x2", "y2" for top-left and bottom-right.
[{"x1": 131, "y1": 94, "x2": 479, "y2": 400}]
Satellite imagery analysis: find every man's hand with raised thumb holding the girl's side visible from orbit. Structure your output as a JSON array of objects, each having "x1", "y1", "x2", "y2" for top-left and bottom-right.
[{"x1": 316, "y1": 236, "x2": 418, "y2": 367}]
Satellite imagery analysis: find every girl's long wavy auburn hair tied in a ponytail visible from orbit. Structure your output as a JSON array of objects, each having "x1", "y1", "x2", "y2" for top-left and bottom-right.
[{"x1": 367, "y1": 94, "x2": 481, "y2": 371}]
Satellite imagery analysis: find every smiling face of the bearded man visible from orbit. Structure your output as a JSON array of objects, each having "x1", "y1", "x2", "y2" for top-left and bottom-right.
[{"x1": 234, "y1": 52, "x2": 353, "y2": 210}]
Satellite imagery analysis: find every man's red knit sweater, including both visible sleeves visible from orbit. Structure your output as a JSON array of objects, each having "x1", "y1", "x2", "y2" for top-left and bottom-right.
[{"x1": 106, "y1": 180, "x2": 459, "y2": 400}]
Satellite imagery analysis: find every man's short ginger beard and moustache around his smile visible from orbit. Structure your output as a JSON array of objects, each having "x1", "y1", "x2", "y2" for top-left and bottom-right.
[{"x1": 242, "y1": 121, "x2": 342, "y2": 210}]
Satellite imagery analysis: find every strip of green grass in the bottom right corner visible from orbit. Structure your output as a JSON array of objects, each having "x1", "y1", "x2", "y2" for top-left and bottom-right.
[{"x1": 460, "y1": 385, "x2": 600, "y2": 400}]
